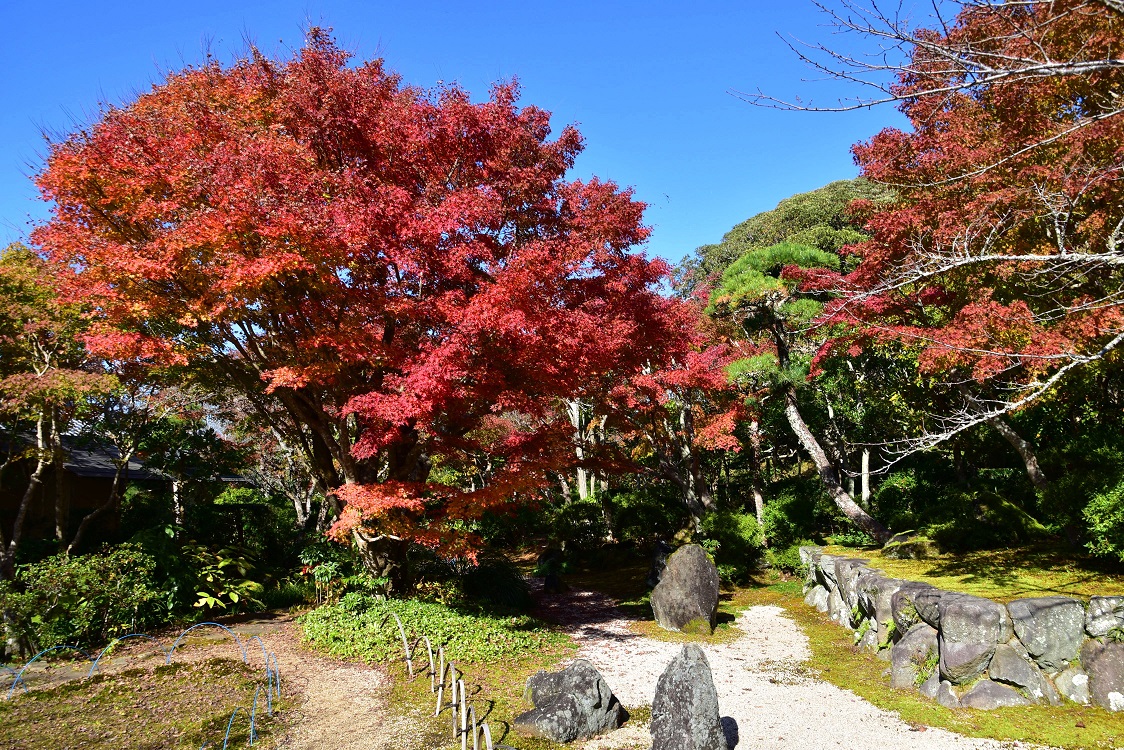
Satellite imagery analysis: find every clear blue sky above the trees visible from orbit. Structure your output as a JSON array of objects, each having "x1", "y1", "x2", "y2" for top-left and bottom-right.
[{"x1": 0, "y1": 0, "x2": 901, "y2": 261}]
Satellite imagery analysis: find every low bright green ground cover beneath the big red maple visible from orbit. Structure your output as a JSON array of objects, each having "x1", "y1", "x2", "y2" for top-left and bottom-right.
[{"x1": 298, "y1": 591, "x2": 565, "y2": 661}]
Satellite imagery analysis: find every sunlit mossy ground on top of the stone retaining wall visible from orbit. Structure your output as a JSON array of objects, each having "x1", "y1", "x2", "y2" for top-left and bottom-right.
[{"x1": 824, "y1": 545, "x2": 1124, "y2": 602}]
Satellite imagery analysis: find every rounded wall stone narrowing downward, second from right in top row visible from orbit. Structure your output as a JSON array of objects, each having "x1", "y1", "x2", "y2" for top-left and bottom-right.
[{"x1": 1007, "y1": 596, "x2": 1085, "y2": 671}]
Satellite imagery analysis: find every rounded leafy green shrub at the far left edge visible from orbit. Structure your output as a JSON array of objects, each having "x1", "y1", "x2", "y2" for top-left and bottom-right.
[{"x1": 0, "y1": 544, "x2": 170, "y2": 649}]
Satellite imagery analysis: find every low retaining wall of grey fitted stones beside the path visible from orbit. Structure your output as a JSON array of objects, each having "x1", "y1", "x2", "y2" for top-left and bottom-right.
[{"x1": 800, "y1": 546, "x2": 1124, "y2": 711}]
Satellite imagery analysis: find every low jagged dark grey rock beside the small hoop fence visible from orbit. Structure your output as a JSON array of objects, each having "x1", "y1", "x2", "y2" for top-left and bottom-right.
[{"x1": 513, "y1": 659, "x2": 628, "y2": 742}]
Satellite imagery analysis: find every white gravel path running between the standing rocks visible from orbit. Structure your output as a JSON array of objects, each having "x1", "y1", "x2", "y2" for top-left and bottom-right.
[{"x1": 541, "y1": 593, "x2": 1030, "y2": 750}]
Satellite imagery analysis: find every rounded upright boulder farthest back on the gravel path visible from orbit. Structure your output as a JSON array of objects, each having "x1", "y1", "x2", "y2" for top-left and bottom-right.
[{"x1": 652, "y1": 544, "x2": 718, "y2": 634}]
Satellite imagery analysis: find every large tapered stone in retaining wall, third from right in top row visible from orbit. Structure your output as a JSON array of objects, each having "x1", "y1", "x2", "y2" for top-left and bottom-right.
[{"x1": 935, "y1": 591, "x2": 1010, "y2": 685}]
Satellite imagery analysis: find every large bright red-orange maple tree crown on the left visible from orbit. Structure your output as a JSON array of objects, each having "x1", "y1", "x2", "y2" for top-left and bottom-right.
[{"x1": 34, "y1": 29, "x2": 679, "y2": 544}]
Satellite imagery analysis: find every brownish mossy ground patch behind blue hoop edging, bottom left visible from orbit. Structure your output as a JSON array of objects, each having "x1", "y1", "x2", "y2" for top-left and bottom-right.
[{"x1": 0, "y1": 659, "x2": 285, "y2": 750}]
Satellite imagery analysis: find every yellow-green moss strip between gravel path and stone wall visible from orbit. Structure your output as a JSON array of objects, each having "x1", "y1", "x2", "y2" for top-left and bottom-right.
[{"x1": 755, "y1": 581, "x2": 1124, "y2": 748}]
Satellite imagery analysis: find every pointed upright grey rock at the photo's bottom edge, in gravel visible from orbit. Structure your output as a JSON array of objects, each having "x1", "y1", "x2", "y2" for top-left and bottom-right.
[{"x1": 651, "y1": 643, "x2": 726, "y2": 750}]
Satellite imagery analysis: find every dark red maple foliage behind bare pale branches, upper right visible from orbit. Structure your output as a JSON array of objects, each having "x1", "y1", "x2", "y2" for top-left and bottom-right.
[{"x1": 808, "y1": 0, "x2": 1124, "y2": 411}]
